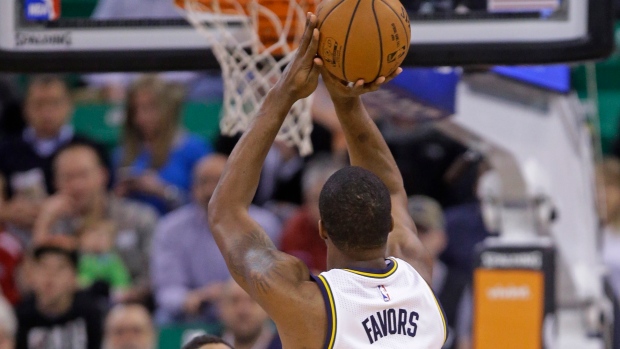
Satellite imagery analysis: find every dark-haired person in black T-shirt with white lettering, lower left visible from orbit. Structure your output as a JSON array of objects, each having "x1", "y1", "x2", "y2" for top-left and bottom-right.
[{"x1": 17, "y1": 236, "x2": 103, "y2": 349}]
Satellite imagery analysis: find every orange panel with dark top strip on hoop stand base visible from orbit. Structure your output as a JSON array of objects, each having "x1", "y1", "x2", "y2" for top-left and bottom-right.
[{"x1": 473, "y1": 246, "x2": 555, "y2": 349}]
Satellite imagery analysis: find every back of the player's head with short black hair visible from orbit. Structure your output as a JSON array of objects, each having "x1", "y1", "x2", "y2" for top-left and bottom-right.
[{"x1": 319, "y1": 166, "x2": 392, "y2": 251}]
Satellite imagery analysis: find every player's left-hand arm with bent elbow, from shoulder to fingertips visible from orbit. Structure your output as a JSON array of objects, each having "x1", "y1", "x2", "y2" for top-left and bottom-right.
[{"x1": 208, "y1": 15, "x2": 321, "y2": 322}]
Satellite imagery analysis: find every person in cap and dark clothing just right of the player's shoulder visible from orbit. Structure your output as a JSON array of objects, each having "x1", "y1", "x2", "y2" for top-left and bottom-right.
[{"x1": 408, "y1": 196, "x2": 472, "y2": 349}]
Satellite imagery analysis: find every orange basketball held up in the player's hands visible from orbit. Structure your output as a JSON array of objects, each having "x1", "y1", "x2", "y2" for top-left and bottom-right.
[{"x1": 317, "y1": 0, "x2": 411, "y2": 82}]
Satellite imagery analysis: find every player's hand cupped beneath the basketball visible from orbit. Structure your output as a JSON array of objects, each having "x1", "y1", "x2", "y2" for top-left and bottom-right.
[{"x1": 321, "y1": 67, "x2": 403, "y2": 102}]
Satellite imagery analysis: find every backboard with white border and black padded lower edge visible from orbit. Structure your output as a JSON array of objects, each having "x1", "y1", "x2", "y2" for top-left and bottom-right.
[{"x1": 0, "y1": 0, "x2": 614, "y2": 72}]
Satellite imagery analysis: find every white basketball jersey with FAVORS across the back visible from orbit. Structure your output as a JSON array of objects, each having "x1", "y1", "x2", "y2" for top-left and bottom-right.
[{"x1": 316, "y1": 257, "x2": 447, "y2": 349}]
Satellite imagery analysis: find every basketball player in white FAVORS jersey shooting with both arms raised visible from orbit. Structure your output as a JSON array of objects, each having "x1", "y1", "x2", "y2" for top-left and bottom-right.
[{"x1": 208, "y1": 14, "x2": 446, "y2": 349}]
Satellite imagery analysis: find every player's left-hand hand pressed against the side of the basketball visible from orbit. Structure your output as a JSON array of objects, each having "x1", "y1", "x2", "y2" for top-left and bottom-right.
[{"x1": 276, "y1": 13, "x2": 323, "y2": 102}]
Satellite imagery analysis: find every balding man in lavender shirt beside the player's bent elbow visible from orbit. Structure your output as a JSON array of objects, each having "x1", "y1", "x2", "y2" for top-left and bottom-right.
[{"x1": 151, "y1": 154, "x2": 280, "y2": 323}]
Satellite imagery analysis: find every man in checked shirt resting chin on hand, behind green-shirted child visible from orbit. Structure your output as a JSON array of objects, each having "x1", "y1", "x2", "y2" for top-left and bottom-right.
[{"x1": 35, "y1": 144, "x2": 157, "y2": 301}]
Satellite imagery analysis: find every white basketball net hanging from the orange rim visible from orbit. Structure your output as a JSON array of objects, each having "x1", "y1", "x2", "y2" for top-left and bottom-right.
[{"x1": 175, "y1": 0, "x2": 313, "y2": 156}]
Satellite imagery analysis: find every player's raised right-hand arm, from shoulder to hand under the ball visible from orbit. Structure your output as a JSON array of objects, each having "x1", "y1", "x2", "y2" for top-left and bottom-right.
[{"x1": 322, "y1": 68, "x2": 432, "y2": 283}]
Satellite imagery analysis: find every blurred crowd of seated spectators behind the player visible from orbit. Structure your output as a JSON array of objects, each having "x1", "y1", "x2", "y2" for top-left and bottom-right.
[{"x1": 0, "y1": 70, "x2": 488, "y2": 349}]
